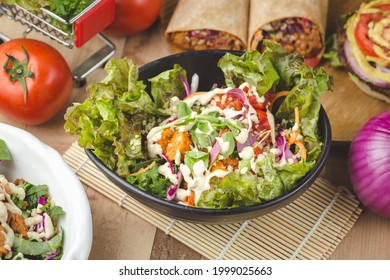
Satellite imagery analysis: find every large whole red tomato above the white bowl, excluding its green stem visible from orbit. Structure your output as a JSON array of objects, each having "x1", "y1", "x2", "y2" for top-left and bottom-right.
[{"x1": 0, "y1": 39, "x2": 73, "y2": 125}]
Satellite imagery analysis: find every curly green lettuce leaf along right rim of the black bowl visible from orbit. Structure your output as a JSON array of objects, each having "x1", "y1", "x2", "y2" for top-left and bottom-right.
[{"x1": 264, "y1": 41, "x2": 333, "y2": 162}]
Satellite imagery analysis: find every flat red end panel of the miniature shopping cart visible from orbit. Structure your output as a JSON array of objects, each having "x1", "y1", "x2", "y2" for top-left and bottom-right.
[{"x1": 75, "y1": 0, "x2": 115, "y2": 48}]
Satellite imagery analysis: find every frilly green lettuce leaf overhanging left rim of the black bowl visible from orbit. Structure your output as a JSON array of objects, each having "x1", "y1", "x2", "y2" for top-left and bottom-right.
[{"x1": 64, "y1": 59, "x2": 161, "y2": 176}]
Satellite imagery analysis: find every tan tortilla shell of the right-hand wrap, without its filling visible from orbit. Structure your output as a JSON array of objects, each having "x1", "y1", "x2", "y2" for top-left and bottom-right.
[{"x1": 248, "y1": 0, "x2": 328, "y2": 60}]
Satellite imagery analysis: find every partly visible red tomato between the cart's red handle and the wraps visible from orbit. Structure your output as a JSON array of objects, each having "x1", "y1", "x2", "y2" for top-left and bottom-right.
[{"x1": 106, "y1": 0, "x2": 162, "y2": 36}]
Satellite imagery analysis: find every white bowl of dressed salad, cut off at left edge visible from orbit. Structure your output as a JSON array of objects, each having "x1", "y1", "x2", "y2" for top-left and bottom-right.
[{"x1": 0, "y1": 123, "x2": 92, "y2": 260}]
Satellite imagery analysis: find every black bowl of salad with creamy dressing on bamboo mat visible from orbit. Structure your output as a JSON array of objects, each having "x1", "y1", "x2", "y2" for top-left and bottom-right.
[{"x1": 65, "y1": 42, "x2": 332, "y2": 223}]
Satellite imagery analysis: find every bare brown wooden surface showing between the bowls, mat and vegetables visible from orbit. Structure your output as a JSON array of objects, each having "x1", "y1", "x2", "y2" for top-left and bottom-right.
[{"x1": 0, "y1": 0, "x2": 390, "y2": 260}]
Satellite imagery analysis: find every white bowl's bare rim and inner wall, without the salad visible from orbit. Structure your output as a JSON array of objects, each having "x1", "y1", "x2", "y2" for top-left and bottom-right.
[{"x1": 0, "y1": 123, "x2": 92, "y2": 260}]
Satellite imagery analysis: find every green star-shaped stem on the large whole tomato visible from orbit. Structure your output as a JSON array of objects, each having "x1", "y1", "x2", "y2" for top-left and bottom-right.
[{"x1": 3, "y1": 46, "x2": 35, "y2": 104}]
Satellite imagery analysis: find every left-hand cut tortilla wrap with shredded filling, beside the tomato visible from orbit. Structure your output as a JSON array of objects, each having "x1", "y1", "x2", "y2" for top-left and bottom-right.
[{"x1": 165, "y1": 0, "x2": 250, "y2": 50}]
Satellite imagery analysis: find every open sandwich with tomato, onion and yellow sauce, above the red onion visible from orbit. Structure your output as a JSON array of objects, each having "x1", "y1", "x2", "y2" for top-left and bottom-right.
[{"x1": 324, "y1": 0, "x2": 390, "y2": 103}]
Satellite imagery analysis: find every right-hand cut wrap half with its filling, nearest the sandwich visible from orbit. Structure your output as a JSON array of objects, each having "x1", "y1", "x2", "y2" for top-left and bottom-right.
[{"x1": 248, "y1": 0, "x2": 328, "y2": 66}]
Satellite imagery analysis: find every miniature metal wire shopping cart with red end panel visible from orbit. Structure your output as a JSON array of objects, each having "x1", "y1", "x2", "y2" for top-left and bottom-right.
[{"x1": 0, "y1": 0, "x2": 115, "y2": 86}]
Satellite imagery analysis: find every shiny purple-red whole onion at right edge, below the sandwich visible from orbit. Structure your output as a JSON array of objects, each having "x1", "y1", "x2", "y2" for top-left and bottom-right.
[{"x1": 348, "y1": 110, "x2": 390, "y2": 218}]
